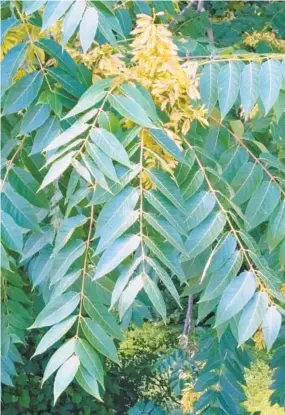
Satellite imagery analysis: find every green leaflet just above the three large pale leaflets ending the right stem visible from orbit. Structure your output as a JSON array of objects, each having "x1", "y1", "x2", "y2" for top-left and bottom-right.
[{"x1": 200, "y1": 251, "x2": 243, "y2": 302}]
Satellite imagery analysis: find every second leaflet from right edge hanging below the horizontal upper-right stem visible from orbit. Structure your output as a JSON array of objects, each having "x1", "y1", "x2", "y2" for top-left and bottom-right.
[{"x1": 240, "y1": 62, "x2": 260, "y2": 115}]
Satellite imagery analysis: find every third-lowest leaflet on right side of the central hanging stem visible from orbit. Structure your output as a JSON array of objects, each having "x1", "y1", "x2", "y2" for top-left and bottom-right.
[{"x1": 144, "y1": 235, "x2": 185, "y2": 282}]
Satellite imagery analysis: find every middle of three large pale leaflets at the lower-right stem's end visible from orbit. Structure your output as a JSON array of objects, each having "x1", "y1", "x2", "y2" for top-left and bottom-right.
[{"x1": 238, "y1": 292, "x2": 268, "y2": 345}]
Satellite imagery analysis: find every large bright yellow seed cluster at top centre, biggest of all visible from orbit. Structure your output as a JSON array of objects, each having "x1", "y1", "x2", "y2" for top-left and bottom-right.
[{"x1": 132, "y1": 15, "x2": 207, "y2": 134}]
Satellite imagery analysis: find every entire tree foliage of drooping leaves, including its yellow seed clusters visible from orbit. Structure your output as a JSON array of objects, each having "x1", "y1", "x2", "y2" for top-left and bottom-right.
[{"x1": 1, "y1": 0, "x2": 285, "y2": 415}]
